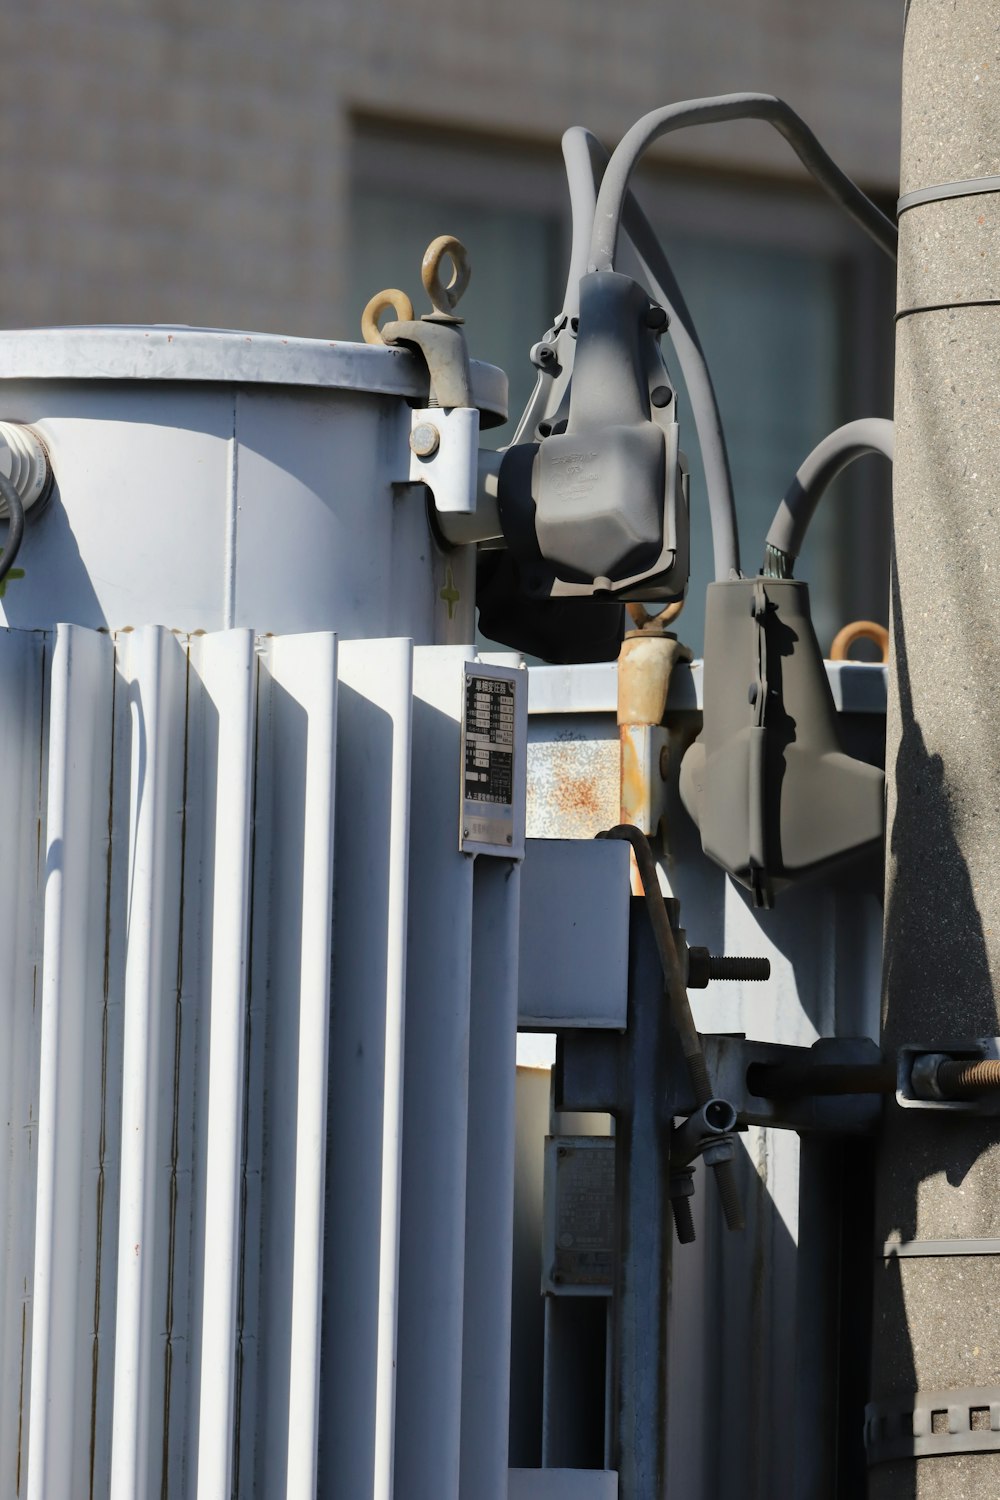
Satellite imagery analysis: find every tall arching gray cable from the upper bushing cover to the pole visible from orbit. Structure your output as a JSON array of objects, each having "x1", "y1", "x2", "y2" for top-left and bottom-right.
[{"x1": 589, "y1": 93, "x2": 898, "y2": 270}]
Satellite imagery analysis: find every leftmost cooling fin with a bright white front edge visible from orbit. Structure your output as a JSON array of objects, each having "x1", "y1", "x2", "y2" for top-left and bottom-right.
[{"x1": 24, "y1": 626, "x2": 114, "y2": 1500}]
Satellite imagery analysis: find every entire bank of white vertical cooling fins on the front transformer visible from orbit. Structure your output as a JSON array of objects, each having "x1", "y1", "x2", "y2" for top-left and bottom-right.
[{"x1": 0, "y1": 626, "x2": 520, "y2": 1500}]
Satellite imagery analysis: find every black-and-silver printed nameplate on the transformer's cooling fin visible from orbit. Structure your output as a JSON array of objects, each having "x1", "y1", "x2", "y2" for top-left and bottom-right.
[{"x1": 459, "y1": 662, "x2": 528, "y2": 860}]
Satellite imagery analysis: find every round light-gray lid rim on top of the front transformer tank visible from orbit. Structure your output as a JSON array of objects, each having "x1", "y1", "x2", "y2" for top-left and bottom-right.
[{"x1": 0, "y1": 324, "x2": 507, "y2": 428}]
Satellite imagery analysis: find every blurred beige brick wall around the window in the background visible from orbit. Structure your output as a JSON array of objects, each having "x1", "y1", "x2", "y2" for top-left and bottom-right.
[{"x1": 0, "y1": 0, "x2": 903, "y2": 335}]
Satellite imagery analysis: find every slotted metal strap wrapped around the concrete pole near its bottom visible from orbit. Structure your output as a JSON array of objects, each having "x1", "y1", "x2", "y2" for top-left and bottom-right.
[{"x1": 865, "y1": 1386, "x2": 1000, "y2": 1466}]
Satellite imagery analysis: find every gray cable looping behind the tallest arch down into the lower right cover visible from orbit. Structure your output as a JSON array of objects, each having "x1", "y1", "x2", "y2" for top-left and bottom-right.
[{"x1": 562, "y1": 125, "x2": 739, "y2": 581}]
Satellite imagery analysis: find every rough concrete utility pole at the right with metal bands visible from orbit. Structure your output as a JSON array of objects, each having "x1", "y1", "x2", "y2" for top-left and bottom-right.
[{"x1": 870, "y1": 0, "x2": 1000, "y2": 1500}]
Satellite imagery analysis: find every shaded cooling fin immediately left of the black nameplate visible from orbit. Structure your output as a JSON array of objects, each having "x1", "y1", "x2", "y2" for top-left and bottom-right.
[{"x1": 394, "y1": 647, "x2": 472, "y2": 1500}]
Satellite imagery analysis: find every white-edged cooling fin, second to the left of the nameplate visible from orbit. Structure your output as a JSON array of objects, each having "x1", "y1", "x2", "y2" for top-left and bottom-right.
[{"x1": 319, "y1": 641, "x2": 412, "y2": 1500}]
